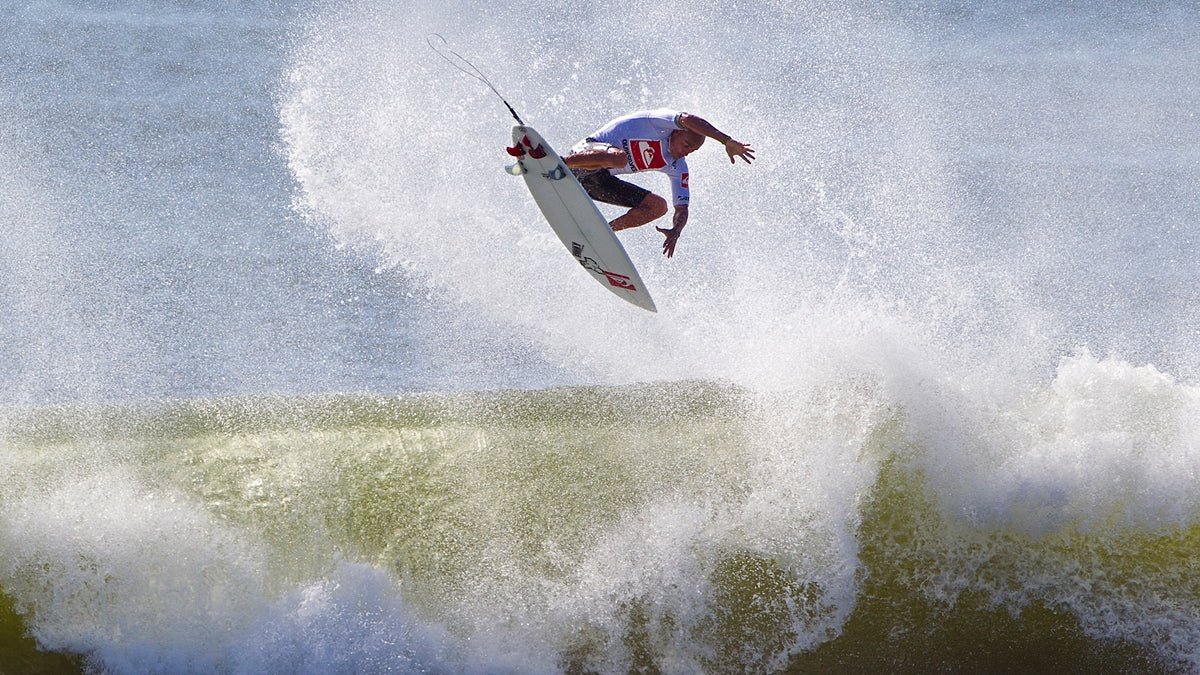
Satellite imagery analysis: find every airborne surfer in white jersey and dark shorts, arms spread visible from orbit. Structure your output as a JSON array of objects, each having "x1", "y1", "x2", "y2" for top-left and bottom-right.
[{"x1": 563, "y1": 109, "x2": 754, "y2": 258}]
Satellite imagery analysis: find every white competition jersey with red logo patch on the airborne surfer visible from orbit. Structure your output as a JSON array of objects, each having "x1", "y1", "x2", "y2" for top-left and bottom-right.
[{"x1": 588, "y1": 108, "x2": 691, "y2": 207}]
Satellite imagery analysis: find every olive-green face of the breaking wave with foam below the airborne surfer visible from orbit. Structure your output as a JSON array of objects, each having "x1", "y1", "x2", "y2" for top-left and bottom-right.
[{"x1": 0, "y1": 381, "x2": 1200, "y2": 673}]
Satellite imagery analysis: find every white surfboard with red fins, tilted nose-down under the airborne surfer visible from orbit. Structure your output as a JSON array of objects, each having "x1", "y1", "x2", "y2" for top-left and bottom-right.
[{"x1": 509, "y1": 125, "x2": 658, "y2": 312}]
